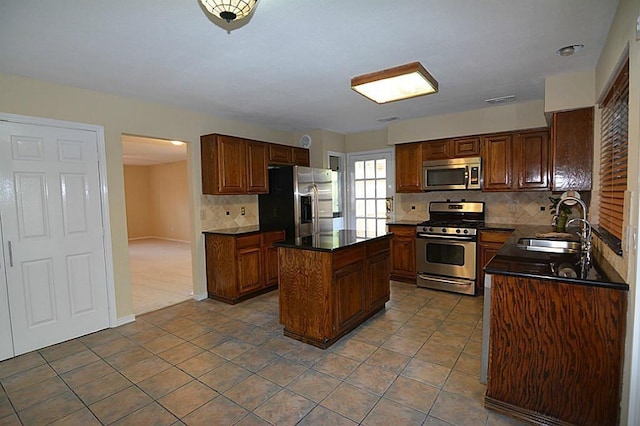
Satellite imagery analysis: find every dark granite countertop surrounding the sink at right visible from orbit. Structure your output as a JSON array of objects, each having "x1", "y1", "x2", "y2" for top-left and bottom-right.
[{"x1": 484, "y1": 225, "x2": 629, "y2": 290}]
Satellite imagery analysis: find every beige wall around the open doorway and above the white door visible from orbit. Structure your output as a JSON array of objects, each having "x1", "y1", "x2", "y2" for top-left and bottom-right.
[{"x1": 0, "y1": 74, "x2": 298, "y2": 320}]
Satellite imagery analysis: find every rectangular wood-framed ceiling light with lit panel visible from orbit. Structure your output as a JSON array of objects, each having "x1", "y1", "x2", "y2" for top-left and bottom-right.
[{"x1": 351, "y1": 62, "x2": 438, "y2": 104}]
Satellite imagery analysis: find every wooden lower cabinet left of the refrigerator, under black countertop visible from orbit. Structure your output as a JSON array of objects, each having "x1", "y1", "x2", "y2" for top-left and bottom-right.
[{"x1": 205, "y1": 231, "x2": 285, "y2": 304}]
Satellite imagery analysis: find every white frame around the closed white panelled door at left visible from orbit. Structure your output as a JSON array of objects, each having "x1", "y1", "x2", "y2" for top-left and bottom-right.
[{"x1": 0, "y1": 112, "x2": 119, "y2": 327}]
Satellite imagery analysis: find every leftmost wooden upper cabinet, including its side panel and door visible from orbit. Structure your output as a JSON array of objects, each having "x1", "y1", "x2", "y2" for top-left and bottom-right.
[{"x1": 200, "y1": 135, "x2": 247, "y2": 194}]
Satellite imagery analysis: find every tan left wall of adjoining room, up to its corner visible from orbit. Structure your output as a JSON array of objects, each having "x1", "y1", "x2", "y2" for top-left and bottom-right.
[{"x1": 124, "y1": 166, "x2": 152, "y2": 239}]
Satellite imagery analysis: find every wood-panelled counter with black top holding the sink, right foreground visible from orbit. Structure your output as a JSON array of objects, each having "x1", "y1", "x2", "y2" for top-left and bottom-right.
[{"x1": 485, "y1": 226, "x2": 629, "y2": 425}]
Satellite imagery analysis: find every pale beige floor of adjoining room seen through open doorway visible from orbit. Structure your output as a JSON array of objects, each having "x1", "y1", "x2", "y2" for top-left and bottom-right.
[{"x1": 129, "y1": 238, "x2": 193, "y2": 315}]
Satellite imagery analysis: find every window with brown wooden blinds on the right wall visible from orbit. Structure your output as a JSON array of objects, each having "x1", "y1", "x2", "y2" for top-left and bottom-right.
[{"x1": 598, "y1": 59, "x2": 629, "y2": 250}]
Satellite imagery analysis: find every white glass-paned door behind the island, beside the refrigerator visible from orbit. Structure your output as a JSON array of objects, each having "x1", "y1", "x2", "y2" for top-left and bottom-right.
[{"x1": 349, "y1": 150, "x2": 395, "y2": 237}]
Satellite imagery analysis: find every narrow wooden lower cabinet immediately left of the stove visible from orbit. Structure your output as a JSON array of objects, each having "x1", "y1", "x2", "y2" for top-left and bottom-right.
[{"x1": 389, "y1": 225, "x2": 416, "y2": 283}]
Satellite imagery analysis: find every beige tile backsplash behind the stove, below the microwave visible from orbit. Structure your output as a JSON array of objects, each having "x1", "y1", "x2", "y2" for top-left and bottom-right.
[{"x1": 394, "y1": 191, "x2": 564, "y2": 225}]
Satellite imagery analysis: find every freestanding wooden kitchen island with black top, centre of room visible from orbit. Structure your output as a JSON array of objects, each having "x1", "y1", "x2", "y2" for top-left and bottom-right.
[{"x1": 274, "y1": 230, "x2": 391, "y2": 349}]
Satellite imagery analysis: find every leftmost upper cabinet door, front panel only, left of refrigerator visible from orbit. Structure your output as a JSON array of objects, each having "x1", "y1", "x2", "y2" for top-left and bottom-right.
[{"x1": 214, "y1": 135, "x2": 247, "y2": 194}]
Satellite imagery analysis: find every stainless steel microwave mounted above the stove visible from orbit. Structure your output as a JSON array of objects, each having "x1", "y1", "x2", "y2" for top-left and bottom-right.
[{"x1": 422, "y1": 157, "x2": 482, "y2": 191}]
